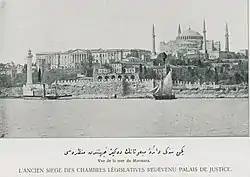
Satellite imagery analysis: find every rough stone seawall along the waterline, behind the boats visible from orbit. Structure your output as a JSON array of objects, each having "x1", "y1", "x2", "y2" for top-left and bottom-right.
[{"x1": 0, "y1": 80, "x2": 248, "y2": 98}]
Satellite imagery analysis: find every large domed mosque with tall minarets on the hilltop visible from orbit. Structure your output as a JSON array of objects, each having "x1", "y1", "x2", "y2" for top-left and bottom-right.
[{"x1": 158, "y1": 20, "x2": 230, "y2": 59}]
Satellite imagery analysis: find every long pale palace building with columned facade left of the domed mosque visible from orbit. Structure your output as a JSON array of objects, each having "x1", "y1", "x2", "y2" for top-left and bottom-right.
[{"x1": 36, "y1": 49, "x2": 151, "y2": 69}]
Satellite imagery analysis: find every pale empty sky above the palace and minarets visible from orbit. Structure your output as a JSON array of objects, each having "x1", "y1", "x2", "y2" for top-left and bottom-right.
[{"x1": 0, "y1": 0, "x2": 248, "y2": 63}]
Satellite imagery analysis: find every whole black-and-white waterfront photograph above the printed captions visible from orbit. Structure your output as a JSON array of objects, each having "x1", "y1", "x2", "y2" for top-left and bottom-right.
[{"x1": 0, "y1": 0, "x2": 249, "y2": 138}]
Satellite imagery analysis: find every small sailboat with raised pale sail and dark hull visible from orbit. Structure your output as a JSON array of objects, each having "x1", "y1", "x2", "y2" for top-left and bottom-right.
[{"x1": 152, "y1": 69, "x2": 176, "y2": 100}]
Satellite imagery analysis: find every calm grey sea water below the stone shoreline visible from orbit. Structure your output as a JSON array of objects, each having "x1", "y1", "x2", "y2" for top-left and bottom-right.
[{"x1": 0, "y1": 99, "x2": 249, "y2": 138}]
